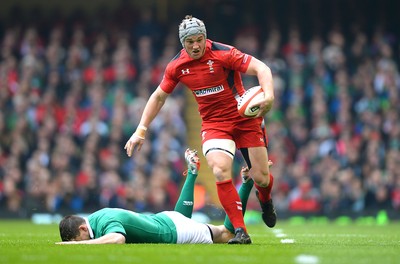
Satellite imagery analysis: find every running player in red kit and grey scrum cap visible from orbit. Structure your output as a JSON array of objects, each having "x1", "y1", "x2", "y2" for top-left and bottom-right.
[{"x1": 125, "y1": 16, "x2": 276, "y2": 244}]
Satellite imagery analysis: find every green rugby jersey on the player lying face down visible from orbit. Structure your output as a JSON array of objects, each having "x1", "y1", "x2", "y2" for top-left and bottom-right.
[{"x1": 87, "y1": 208, "x2": 177, "y2": 244}]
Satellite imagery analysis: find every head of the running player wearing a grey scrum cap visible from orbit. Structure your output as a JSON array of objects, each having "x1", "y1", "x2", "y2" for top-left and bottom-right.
[{"x1": 179, "y1": 15, "x2": 207, "y2": 59}]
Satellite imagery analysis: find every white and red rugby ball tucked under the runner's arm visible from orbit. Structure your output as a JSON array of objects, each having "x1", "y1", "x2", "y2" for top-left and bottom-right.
[{"x1": 238, "y1": 86, "x2": 264, "y2": 117}]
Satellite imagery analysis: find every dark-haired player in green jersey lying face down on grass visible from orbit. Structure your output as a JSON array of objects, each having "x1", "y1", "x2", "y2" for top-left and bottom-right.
[{"x1": 57, "y1": 149, "x2": 268, "y2": 244}]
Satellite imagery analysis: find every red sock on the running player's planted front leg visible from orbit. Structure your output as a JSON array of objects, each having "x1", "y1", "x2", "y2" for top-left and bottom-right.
[{"x1": 217, "y1": 180, "x2": 247, "y2": 232}]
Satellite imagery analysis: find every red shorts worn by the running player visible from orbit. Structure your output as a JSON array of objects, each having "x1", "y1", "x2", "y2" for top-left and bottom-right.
[{"x1": 201, "y1": 117, "x2": 268, "y2": 149}]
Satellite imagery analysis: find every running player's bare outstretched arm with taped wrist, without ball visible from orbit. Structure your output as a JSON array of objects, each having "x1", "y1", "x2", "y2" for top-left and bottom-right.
[{"x1": 124, "y1": 86, "x2": 168, "y2": 157}]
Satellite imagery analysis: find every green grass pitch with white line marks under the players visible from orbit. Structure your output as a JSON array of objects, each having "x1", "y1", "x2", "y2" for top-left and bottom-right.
[{"x1": 0, "y1": 220, "x2": 400, "y2": 264}]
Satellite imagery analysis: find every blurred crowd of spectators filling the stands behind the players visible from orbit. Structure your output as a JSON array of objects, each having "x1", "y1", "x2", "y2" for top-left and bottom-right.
[{"x1": 0, "y1": 0, "x2": 400, "y2": 221}]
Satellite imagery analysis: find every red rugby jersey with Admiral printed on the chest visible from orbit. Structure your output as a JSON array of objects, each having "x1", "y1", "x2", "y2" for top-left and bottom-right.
[{"x1": 160, "y1": 39, "x2": 252, "y2": 122}]
